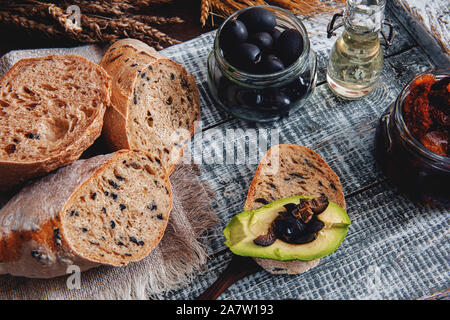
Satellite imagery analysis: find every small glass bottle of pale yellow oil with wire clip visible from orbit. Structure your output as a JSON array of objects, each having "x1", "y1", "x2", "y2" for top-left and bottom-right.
[{"x1": 327, "y1": 0, "x2": 385, "y2": 99}]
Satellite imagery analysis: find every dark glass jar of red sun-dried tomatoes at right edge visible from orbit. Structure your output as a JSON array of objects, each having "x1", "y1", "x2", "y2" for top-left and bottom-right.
[{"x1": 376, "y1": 69, "x2": 450, "y2": 208}]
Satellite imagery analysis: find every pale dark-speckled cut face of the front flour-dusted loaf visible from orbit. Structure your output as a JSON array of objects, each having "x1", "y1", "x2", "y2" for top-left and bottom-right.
[{"x1": 61, "y1": 151, "x2": 172, "y2": 266}]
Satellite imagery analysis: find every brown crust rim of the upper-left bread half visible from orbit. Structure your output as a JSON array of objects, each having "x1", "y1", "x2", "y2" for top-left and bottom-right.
[{"x1": 0, "y1": 55, "x2": 111, "y2": 191}]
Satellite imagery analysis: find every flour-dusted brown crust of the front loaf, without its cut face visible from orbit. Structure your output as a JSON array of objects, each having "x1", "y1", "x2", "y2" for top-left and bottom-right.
[{"x1": 0, "y1": 150, "x2": 172, "y2": 278}]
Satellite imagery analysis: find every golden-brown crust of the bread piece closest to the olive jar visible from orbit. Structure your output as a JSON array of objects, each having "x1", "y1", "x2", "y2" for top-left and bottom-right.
[{"x1": 100, "y1": 39, "x2": 200, "y2": 174}]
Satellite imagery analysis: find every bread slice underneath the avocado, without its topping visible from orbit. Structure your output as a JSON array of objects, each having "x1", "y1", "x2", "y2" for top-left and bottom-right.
[{"x1": 245, "y1": 144, "x2": 345, "y2": 274}]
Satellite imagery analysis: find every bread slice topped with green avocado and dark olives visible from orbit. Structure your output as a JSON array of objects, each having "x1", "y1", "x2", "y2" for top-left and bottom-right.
[{"x1": 224, "y1": 144, "x2": 350, "y2": 274}]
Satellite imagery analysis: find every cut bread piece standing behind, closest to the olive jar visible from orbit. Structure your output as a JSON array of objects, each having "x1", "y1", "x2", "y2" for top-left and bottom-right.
[{"x1": 100, "y1": 39, "x2": 200, "y2": 174}]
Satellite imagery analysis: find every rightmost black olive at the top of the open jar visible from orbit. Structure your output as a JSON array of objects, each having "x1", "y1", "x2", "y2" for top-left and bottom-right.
[{"x1": 274, "y1": 29, "x2": 303, "y2": 66}]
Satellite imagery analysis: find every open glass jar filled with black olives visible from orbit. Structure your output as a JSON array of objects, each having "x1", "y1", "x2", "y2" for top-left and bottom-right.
[{"x1": 207, "y1": 6, "x2": 317, "y2": 122}]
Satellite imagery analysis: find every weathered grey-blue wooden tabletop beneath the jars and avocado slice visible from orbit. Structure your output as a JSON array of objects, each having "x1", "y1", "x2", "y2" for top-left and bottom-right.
[{"x1": 153, "y1": 1, "x2": 450, "y2": 300}]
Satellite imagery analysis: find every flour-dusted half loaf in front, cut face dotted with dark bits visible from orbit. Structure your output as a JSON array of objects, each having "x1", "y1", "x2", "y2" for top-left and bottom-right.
[{"x1": 0, "y1": 150, "x2": 172, "y2": 278}]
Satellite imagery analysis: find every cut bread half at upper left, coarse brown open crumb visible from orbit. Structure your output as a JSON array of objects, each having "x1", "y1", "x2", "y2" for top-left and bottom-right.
[{"x1": 0, "y1": 55, "x2": 111, "y2": 190}]
